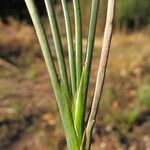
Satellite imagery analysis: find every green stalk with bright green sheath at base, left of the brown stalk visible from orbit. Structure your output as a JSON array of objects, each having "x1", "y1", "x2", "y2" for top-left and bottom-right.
[{"x1": 75, "y1": 0, "x2": 100, "y2": 143}]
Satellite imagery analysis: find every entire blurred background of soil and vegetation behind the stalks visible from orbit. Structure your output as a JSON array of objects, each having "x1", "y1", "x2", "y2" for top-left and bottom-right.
[{"x1": 0, "y1": 0, "x2": 150, "y2": 150}]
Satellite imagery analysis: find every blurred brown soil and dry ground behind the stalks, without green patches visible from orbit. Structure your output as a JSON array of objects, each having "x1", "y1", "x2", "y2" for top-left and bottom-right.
[{"x1": 0, "y1": 18, "x2": 150, "y2": 150}]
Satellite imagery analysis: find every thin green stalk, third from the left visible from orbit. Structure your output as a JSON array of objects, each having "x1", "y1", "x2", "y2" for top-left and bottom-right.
[{"x1": 61, "y1": 0, "x2": 76, "y2": 97}]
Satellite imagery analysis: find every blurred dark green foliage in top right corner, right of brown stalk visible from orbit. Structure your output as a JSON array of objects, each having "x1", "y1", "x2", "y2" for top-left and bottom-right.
[{"x1": 116, "y1": 0, "x2": 150, "y2": 29}]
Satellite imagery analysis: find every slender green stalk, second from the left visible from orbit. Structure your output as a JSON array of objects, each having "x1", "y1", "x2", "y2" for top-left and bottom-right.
[{"x1": 44, "y1": 0, "x2": 70, "y2": 95}]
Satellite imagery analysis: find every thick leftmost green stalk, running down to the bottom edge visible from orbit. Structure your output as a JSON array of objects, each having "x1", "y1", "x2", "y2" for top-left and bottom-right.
[{"x1": 25, "y1": 0, "x2": 79, "y2": 150}]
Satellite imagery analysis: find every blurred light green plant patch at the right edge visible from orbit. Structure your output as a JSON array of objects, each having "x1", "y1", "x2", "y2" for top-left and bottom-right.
[{"x1": 137, "y1": 84, "x2": 150, "y2": 106}]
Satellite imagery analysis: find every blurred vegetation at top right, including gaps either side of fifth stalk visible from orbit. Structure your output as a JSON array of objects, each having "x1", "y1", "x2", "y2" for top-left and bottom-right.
[{"x1": 81, "y1": 0, "x2": 150, "y2": 31}]
